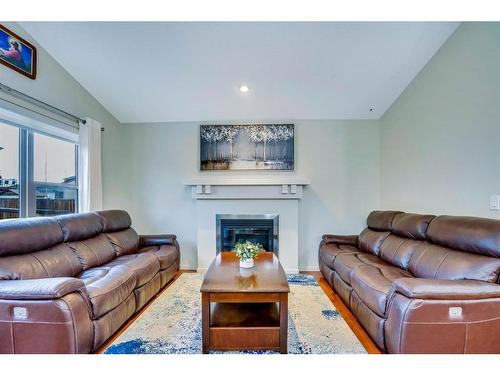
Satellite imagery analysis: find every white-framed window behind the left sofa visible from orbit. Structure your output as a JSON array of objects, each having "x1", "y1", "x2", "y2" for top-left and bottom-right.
[{"x1": 0, "y1": 123, "x2": 78, "y2": 219}]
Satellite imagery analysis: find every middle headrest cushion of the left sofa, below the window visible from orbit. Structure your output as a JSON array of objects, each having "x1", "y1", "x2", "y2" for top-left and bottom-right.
[{"x1": 55, "y1": 212, "x2": 102, "y2": 242}]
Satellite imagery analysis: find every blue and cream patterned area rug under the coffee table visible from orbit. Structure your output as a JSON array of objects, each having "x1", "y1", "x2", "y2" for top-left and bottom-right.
[{"x1": 104, "y1": 273, "x2": 366, "y2": 354}]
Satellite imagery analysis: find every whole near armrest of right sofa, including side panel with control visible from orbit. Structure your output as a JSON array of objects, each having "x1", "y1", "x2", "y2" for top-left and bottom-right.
[{"x1": 384, "y1": 278, "x2": 500, "y2": 354}]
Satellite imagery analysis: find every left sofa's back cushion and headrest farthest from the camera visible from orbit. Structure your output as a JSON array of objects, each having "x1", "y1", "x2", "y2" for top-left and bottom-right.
[{"x1": 97, "y1": 210, "x2": 139, "y2": 256}]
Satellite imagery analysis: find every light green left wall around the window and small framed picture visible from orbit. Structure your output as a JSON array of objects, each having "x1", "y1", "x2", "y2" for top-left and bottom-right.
[{"x1": 0, "y1": 22, "x2": 125, "y2": 207}]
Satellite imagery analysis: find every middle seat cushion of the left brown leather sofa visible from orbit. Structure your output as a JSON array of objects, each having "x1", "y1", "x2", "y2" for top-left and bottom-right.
[{"x1": 105, "y1": 253, "x2": 160, "y2": 288}]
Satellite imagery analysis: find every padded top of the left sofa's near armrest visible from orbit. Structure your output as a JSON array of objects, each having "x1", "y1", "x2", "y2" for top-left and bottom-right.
[{"x1": 0, "y1": 277, "x2": 84, "y2": 300}]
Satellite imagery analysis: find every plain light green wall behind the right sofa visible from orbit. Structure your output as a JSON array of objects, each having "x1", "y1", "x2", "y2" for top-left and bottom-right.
[{"x1": 380, "y1": 23, "x2": 500, "y2": 218}]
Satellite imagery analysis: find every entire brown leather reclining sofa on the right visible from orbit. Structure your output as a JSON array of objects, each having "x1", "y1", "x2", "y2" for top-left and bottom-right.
[{"x1": 319, "y1": 211, "x2": 500, "y2": 353}]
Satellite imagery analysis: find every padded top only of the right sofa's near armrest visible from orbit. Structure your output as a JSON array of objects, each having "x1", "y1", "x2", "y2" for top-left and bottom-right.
[{"x1": 390, "y1": 278, "x2": 500, "y2": 300}]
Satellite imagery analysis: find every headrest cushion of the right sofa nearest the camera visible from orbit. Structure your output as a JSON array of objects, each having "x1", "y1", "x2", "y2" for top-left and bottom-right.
[{"x1": 427, "y1": 216, "x2": 500, "y2": 257}]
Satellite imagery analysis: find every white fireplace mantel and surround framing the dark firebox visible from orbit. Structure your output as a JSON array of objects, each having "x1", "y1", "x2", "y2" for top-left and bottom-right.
[{"x1": 184, "y1": 175, "x2": 309, "y2": 273}]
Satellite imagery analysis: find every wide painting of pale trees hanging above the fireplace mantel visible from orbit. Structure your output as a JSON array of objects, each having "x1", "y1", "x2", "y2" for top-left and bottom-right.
[{"x1": 200, "y1": 124, "x2": 294, "y2": 171}]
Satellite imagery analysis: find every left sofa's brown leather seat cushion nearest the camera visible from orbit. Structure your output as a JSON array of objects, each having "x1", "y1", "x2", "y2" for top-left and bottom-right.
[{"x1": 79, "y1": 266, "x2": 136, "y2": 319}]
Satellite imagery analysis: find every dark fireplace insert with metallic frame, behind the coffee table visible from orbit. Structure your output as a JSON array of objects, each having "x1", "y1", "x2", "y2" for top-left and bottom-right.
[{"x1": 216, "y1": 214, "x2": 278, "y2": 255}]
